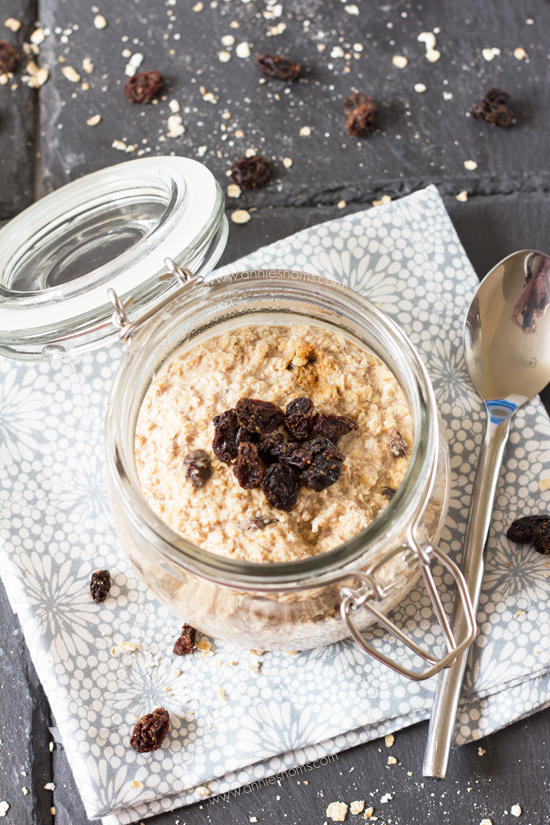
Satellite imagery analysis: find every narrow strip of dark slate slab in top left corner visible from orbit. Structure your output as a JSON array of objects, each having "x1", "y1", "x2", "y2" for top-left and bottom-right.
[{"x1": 0, "y1": 0, "x2": 37, "y2": 220}]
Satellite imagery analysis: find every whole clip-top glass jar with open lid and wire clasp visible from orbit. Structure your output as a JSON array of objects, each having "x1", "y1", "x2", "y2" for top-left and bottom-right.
[{"x1": 0, "y1": 157, "x2": 474, "y2": 679}]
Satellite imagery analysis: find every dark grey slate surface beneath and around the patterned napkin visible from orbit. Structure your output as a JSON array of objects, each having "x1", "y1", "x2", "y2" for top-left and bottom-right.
[{"x1": 0, "y1": 0, "x2": 550, "y2": 825}]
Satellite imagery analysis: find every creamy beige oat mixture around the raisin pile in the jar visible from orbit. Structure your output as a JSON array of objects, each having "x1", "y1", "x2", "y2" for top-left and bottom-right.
[{"x1": 135, "y1": 325, "x2": 412, "y2": 562}]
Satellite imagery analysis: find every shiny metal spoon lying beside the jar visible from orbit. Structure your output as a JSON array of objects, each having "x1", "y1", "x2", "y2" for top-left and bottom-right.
[{"x1": 424, "y1": 250, "x2": 550, "y2": 779}]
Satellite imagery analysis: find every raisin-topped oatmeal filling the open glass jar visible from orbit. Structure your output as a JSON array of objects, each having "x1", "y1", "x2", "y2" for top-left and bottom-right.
[{"x1": 135, "y1": 325, "x2": 413, "y2": 562}]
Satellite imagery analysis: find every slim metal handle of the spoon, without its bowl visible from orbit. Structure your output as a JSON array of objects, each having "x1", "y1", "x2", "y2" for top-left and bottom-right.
[{"x1": 423, "y1": 415, "x2": 512, "y2": 779}]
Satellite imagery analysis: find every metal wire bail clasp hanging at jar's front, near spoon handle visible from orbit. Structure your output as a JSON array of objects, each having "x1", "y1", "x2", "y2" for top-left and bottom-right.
[{"x1": 340, "y1": 536, "x2": 476, "y2": 682}]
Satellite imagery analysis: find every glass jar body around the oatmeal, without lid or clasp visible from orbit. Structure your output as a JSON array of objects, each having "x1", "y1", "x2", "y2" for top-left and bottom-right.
[{"x1": 106, "y1": 270, "x2": 472, "y2": 680}]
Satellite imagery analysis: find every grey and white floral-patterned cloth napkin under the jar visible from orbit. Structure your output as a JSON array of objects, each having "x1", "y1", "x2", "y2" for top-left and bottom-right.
[{"x1": 0, "y1": 186, "x2": 550, "y2": 825}]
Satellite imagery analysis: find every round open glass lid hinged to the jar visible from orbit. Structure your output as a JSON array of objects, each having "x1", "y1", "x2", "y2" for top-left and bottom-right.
[{"x1": 0, "y1": 157, "x2": 227, "y2": 359}]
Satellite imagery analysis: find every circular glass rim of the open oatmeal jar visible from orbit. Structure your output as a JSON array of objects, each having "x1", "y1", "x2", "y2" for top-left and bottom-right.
[{"x1": 105, "y1": 269, "x2": 439, "y2": 591}]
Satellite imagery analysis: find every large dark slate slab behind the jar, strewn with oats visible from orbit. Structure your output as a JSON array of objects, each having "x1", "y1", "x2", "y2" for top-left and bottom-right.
[{"x1": 41, "y1": 0, "x2": 550, "y2": 206}]
